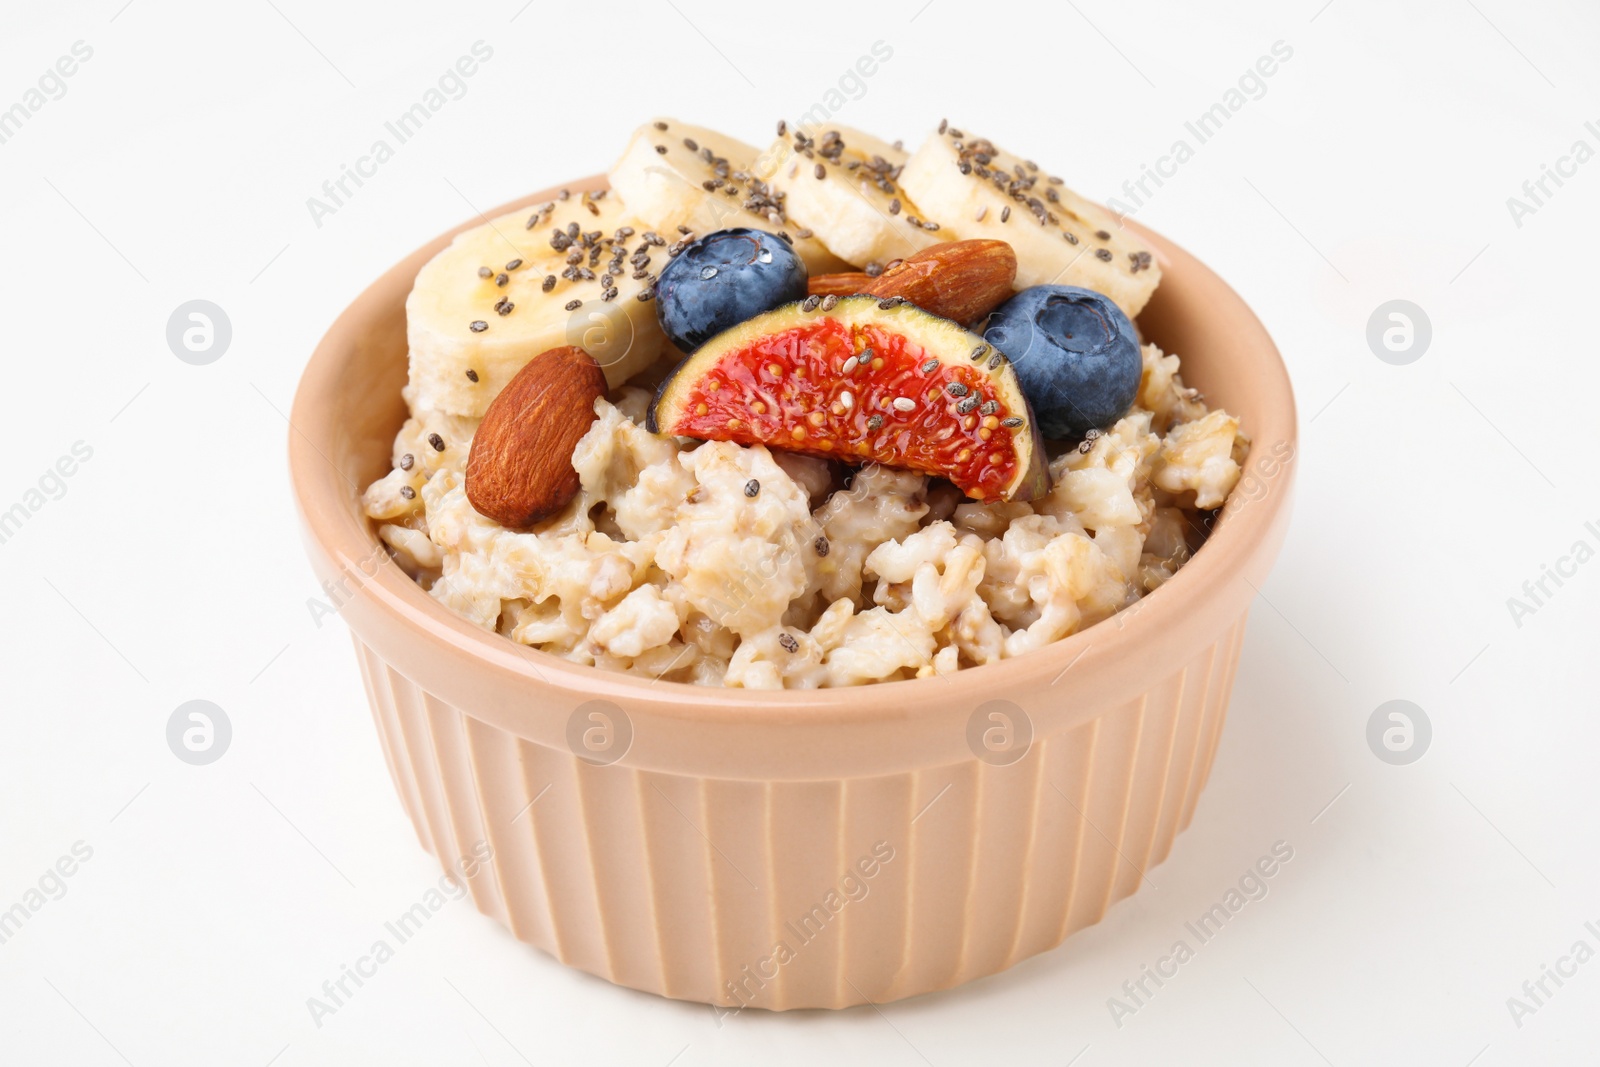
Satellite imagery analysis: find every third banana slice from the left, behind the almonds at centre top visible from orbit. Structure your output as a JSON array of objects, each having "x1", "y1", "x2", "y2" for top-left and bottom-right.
[{"x1": 755, "y1": 123, "x2": 950, "y2": 267}]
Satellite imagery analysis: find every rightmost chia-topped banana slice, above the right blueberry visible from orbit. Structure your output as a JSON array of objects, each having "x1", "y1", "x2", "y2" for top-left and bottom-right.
[{"x1": 901, "y1": 125, "x2": 1162, "y2": 318}]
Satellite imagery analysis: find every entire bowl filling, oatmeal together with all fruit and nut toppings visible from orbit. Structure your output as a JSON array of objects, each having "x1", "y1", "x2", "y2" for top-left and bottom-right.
[{"x1": 363, "y1": 120, "x2": 1248, "y2": 688}]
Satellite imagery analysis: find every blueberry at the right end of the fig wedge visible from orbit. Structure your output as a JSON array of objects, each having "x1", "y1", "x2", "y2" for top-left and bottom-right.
[{"x1": 984, "y1": 285, "x2": 1144, "y2": 438}]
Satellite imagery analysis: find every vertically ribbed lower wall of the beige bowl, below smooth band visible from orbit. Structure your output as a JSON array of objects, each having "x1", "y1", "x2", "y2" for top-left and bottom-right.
[{"x1": 355, "y1": 614, "x2": 1245, "y2": 1011}]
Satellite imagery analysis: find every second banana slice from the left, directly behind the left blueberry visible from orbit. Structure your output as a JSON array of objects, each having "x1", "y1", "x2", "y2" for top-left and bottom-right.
[{"x1": 611, "y1": 118, "x2": 848, "y2": 274}]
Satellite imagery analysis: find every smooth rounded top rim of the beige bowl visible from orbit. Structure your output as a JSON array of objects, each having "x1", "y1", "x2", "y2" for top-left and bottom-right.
[{"x1": 288, "y1": 174, "x2": 1299, "y2": 725}]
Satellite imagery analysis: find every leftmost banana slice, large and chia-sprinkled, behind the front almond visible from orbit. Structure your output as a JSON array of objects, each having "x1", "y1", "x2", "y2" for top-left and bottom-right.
[{"x1": 405, "y1": 192, "x2": 667, "y2": 418}]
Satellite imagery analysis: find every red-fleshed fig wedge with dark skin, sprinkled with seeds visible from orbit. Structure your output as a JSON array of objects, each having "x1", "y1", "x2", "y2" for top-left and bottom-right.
[{"x1": 646, "y1": 296, "x2": 1050, "y2": 501}]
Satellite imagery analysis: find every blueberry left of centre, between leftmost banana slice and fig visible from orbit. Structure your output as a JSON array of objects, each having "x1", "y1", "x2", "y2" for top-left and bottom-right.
[{"x1": 656, "y1": 229, "x2": 806, "y2": 352}]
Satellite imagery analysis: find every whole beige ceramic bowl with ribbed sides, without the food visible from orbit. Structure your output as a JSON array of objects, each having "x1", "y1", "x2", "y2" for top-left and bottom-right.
[{"x1": 290, "y1": 178, "x2": 1296, "y2": 1009}]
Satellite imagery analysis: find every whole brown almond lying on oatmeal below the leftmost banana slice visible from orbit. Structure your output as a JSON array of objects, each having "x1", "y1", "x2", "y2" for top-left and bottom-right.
[{"x1": 467, "y1": 346, "x2": 605, "y2": 530}]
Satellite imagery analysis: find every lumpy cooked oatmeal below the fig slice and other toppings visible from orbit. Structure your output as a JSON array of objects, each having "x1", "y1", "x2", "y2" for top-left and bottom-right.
[{"x1": 365, "y1": 344, "x2": 1246, "y2": 688}]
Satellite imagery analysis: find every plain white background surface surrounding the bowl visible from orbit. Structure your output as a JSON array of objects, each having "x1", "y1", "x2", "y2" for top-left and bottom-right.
[{"x1": 0, "y1": 0, "x2": 1600, "y2": 1067}]
